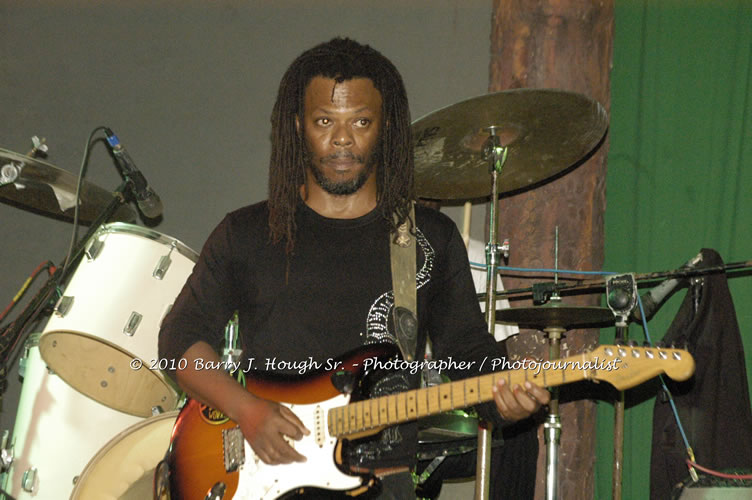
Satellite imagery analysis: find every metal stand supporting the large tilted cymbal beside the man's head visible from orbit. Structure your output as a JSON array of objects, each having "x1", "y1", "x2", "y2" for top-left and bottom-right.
[{"x1": 475, "y1": 126, "x2": 508, "y2": 500}]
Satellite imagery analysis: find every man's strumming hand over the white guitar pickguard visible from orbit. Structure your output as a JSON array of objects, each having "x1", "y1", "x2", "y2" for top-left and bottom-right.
[{"x1": 237, "y1": 394, "x2": 311, "y2": 465}]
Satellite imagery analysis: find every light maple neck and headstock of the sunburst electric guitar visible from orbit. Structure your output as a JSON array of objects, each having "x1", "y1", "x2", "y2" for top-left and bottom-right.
[{"x1": 327, "y1": 345, "x2": 695, "y2": 437}]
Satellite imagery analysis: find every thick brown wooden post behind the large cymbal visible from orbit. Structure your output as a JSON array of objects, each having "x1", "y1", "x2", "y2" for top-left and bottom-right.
[{"x1": 489, "y1": 0, "x2": 613, "y2": 499}]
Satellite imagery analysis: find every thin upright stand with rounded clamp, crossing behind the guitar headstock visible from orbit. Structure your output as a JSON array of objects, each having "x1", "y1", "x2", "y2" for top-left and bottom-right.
[{"x1": 606, "y1": 274, "x2": 637, "y2": 500}]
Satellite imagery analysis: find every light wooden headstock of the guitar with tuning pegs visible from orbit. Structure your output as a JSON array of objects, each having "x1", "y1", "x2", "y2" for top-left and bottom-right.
[{"x1": 584, "y1": 345, "x2": 695, "y2": 390}]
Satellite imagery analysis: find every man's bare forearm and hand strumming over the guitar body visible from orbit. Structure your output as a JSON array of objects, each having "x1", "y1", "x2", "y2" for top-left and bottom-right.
[{"x1": 175, "y1": 342, "x2": 310, "y2": 465}]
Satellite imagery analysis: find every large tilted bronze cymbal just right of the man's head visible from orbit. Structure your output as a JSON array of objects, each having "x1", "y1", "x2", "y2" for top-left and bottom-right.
[{"x1": 412, "y1": 89, "x2": 608, "y2": 200}]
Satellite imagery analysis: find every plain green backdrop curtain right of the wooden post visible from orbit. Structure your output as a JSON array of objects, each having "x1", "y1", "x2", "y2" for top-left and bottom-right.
[{"x1": 595, "y1": 0, "x2": 752, "y2": 500}]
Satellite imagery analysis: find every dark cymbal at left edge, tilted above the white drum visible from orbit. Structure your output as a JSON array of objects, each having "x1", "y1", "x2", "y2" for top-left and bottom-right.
[{"x1": 0, "y1": 148, "x2": 136, "y2": 225}]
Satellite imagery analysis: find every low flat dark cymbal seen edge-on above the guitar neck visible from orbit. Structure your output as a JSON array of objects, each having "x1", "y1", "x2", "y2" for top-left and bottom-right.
[{"x1": 496, "y1": 302, "x2": 615, "y2": 330}]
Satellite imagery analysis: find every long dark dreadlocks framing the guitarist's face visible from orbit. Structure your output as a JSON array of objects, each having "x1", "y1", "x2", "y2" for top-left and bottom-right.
[{"x1": 268, "y1": 38, "x2": 414, "y2": 255}]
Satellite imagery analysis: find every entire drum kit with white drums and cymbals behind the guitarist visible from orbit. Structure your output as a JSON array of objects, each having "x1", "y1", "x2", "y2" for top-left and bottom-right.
[{"x1": 0, "y1": 89, "x2": 700, "y2": 499}]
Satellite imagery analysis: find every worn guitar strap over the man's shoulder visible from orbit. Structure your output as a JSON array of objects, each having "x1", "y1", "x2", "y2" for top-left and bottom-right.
[{"x1": 389, "y1": 202, "x2": 418, "y2": 361}]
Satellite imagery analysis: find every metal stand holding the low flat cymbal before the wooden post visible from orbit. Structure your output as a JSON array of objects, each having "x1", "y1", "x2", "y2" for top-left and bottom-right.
[{"x1": 543, "y1": 230, "x2": 566, "y2": 500}]
